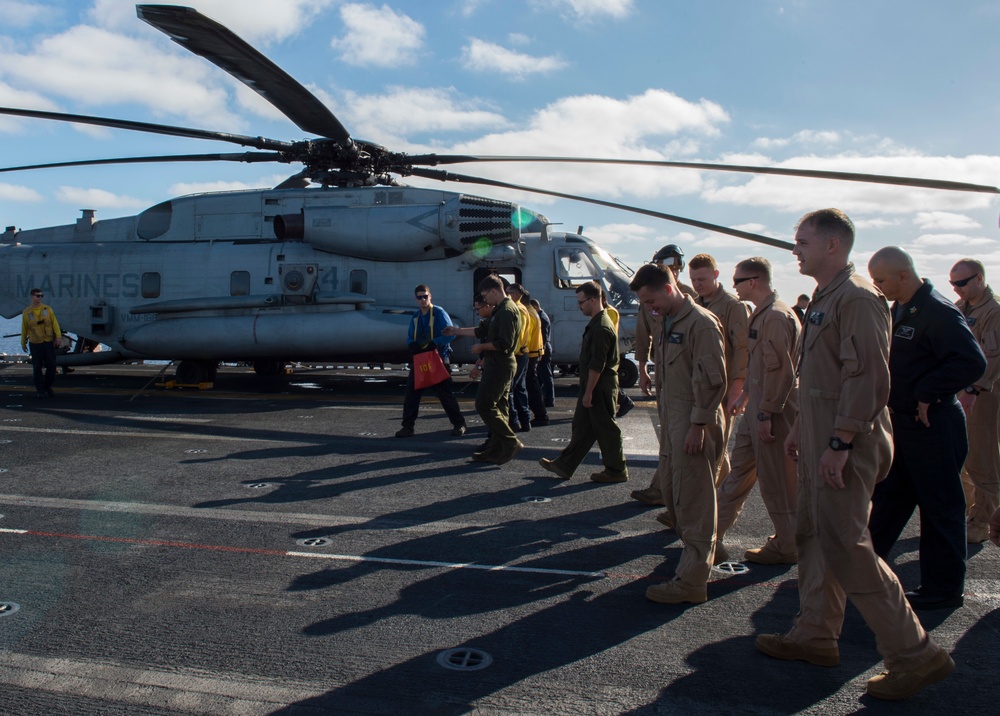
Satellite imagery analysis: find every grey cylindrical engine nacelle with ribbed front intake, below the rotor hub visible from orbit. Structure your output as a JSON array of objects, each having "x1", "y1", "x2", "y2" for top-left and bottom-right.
[{"x1": 274, "y1": 194, "x2": 521, "y2": 261}]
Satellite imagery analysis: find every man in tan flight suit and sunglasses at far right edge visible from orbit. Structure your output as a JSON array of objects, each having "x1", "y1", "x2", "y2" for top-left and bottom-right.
[{"x1": 949, "y1": 259, "x2": 1000, "y2": 544}]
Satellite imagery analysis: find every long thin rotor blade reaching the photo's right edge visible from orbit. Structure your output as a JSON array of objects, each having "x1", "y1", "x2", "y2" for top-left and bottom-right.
[{"x1": 406, "y1": 154, "x2": 1000, "y2": 194}]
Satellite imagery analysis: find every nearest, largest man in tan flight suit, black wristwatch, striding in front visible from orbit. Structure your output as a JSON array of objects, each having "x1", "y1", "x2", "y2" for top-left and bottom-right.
[{"x1": 756, "y1": 209, "x2": 955, "y2": 700}]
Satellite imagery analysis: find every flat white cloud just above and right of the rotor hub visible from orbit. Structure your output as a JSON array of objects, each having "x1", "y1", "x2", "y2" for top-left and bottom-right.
[{"x1": 344, "y1": 87, "x2": 507, "y2": 143}]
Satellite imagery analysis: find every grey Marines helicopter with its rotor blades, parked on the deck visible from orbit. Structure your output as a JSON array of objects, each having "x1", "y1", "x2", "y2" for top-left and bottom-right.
[{"x1": 0, "y1": 5, "x2": 1000, "y2": 387}]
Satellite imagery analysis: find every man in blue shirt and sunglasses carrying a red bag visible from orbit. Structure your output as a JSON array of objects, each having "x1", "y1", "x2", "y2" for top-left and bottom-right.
[{"x1": 396, "y1": 284, "x2": 465, "y2": 438}]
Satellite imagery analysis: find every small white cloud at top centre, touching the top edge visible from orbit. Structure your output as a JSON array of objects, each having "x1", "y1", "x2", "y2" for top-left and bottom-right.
[{"x1": 330, "y1": 3, "x2": 426, "y2": 67}]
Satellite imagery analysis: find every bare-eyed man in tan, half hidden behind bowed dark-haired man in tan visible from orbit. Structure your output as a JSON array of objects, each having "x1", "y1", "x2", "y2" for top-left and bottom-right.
[{"x1": 688, "y1": 254, "x2": 750, "y2": 484}]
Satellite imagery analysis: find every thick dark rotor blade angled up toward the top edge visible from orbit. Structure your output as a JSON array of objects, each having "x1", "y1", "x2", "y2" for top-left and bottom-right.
[{"x1": 136, "y1": 5, "x2": 351, "y2": 145}]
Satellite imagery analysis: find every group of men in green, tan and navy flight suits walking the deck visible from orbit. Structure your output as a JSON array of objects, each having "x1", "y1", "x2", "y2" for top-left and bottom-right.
[{"x1": 404, "y1": 209, "x2": 1000, "y2": 700}]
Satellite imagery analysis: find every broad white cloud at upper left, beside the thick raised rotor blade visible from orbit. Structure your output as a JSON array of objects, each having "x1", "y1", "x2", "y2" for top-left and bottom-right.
[{"x1": 0, "y1": 25, "x2": 242, "y2": 127}]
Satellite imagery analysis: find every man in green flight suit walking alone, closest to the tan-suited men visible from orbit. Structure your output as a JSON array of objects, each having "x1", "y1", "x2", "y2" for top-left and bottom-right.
[{"x1": 539, "y1": 281, "x2": 628, "y2": 482}]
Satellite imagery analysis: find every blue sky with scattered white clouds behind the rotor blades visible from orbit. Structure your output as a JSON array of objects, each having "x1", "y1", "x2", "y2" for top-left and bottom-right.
[{"x1": 0, "y1": 0, "x2": 1000, "y2": 302}]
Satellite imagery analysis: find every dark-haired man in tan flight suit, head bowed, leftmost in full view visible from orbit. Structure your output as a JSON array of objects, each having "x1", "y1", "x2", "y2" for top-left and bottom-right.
[{"x1": 629, "y1": 264, "x2": 726, "y2": 604}]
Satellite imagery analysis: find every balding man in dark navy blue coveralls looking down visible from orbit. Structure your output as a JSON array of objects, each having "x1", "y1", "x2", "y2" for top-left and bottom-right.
[{"x1": 868, "y1": 246, "x2": 986, "y2": 609}]
